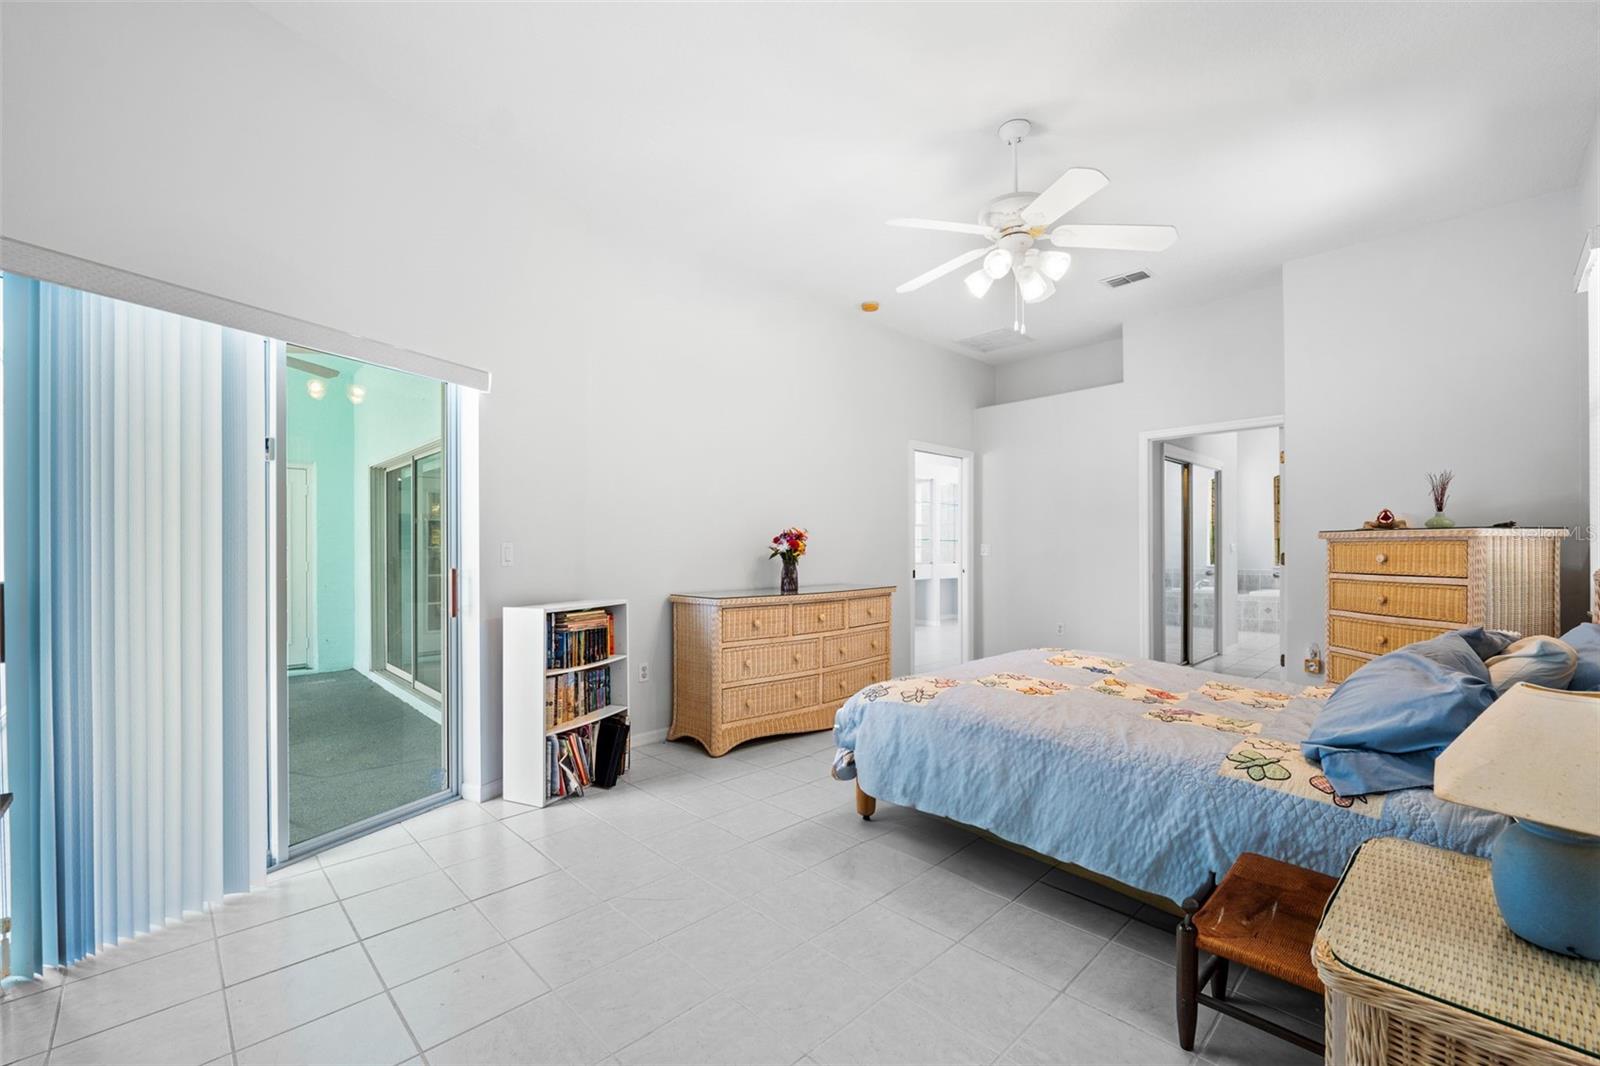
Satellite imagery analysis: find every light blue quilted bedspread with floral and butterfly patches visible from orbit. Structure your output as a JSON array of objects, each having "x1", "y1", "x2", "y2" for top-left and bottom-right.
[{"x1": 834, "y1": 648, "x2": 1506, "y2": 901}]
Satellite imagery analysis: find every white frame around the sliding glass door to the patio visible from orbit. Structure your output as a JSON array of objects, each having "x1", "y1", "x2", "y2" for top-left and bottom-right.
[{"x1": 266, "y1": 361, "x2": 464, "y2": 871}]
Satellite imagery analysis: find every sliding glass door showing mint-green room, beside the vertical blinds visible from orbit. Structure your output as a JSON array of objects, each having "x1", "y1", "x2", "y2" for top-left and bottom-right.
[{"x1": 272, "y1": 347, "x2": 458, "y2": 861}]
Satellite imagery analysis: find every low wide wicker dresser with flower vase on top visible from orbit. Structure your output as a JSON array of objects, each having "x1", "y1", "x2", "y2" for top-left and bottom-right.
[{"x1": 667, "y1": 584, "x2": 894, "y2": 755}]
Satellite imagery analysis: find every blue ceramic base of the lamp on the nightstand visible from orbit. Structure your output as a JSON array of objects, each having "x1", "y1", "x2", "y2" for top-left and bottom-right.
[{"x1": 1491, "y1": 821, "x2": 1600, "y2": 959}]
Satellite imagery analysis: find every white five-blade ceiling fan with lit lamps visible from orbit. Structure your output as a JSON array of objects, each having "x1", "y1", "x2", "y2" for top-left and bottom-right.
[{"x1": 890, "y1": 118, "x2": 1178, "y2": 333}]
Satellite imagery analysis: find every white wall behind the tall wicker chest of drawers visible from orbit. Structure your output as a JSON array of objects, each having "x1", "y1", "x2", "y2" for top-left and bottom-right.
[{"x1": 1283, "y1": 185, "x2": 1587, "y2": 674}]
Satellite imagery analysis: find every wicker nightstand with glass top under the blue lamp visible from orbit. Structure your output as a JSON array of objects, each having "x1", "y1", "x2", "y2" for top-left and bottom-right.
[{"x1": 1312, "y1": 837, "x2": 1600, "y2": 1066}]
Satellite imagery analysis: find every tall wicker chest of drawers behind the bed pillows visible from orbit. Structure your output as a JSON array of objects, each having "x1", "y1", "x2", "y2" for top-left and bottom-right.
[{"x1": 1318, "y1": 527, "x2": 1566, "y2": 682}]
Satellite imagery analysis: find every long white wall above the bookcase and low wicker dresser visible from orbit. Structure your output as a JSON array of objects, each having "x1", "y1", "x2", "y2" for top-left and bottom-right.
[{"x1": 0, "y1": 5, "x2": 994, "y2": 797}]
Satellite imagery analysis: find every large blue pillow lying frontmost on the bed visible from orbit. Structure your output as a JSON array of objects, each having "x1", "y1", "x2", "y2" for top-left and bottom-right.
[{"x1": 1301, "y1": 631, "x2": 1494, "y2": 795}]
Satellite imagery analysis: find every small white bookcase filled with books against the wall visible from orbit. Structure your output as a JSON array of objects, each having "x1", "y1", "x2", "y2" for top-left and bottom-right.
[{"x1": 501, "y1": 600, "x2": 629, "y2": 807}]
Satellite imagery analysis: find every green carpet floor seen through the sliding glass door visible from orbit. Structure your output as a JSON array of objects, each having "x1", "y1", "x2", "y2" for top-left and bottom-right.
[{"x1": 290, "y1": 671, "x2": 445, "y2": 844}]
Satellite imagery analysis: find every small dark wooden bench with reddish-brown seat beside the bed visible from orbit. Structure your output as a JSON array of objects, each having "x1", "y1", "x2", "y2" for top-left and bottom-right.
[{"x1": 1178, "y1": 852, "x2": 1338, "y2": 1055}]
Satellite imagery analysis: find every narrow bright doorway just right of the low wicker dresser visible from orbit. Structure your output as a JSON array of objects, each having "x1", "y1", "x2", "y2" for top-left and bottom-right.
[{"x1": 910, "y1": 445, "x2": 971, "y2": 674}]
